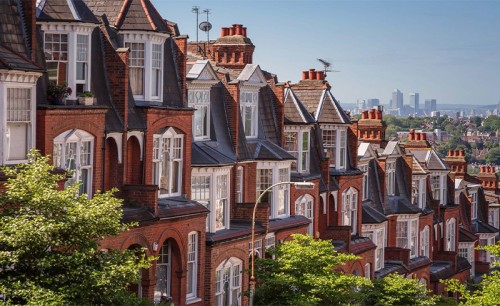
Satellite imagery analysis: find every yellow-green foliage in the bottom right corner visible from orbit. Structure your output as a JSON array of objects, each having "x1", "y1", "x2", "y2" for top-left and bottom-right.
[{"x1": 442, "y1": 244, "x2": 500, "y2": 306}]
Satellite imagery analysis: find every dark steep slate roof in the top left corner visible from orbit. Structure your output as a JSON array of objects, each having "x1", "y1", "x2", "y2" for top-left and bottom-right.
[{"x1": 0, "y1": 0, "x2": 43, "y2": 71}]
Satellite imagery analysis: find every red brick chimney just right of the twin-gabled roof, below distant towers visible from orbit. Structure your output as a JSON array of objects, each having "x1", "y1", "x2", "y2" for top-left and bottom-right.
[{"x1": 358, "y1": 107, "x2": 387, "y2": 147}]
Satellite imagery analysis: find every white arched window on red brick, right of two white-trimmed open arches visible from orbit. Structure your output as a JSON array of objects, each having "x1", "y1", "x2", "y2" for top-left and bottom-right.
[{"x1": 153, "y1": 128, "x2": 184, "y2": 197}]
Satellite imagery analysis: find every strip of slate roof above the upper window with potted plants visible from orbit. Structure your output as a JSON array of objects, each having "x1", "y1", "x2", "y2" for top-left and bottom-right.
[{"x1": 37, "y1": 0, "x2": 99, "y2": 23}]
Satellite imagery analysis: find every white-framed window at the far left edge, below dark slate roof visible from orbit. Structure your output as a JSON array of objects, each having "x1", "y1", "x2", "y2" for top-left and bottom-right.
[{"x1": 0, "y1": 87, "x2": 36, "y2": 165}]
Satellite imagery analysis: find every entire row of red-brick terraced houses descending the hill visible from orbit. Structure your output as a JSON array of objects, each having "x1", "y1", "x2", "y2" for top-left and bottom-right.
[{"x1": 0, "y1": 0, "x2": 500, "y2": 305}]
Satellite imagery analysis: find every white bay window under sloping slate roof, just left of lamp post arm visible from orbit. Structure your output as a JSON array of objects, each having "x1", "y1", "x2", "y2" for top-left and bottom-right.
[{"x1": 191, "y1": 167, "x2": 231, "y2": 233}]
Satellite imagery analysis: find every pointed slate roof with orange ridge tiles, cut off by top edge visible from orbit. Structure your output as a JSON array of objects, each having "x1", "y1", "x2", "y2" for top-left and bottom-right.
[{"x1": 85, "y1": 0, "x2": 171, "y2": 34}]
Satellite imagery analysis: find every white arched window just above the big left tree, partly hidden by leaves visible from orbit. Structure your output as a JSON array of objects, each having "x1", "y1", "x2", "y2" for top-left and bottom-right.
[{"x1": 53, "y1": 130, "x2": 94, "y2": 195}]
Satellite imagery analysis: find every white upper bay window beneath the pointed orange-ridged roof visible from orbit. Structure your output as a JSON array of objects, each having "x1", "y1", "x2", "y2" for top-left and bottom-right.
[{"x1": 122, "y1": 32, "x2": 166, "y2": 103}]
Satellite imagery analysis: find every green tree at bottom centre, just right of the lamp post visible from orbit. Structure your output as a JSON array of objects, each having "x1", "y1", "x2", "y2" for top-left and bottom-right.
[{"x1": 255, "y1": 234, "x2": 370, "y2": 305}]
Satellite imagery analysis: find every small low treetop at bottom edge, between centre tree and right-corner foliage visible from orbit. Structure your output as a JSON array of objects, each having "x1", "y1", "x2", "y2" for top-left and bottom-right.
[{"x1": 361, "y1": 273, "x2": 436, "y2": 306}]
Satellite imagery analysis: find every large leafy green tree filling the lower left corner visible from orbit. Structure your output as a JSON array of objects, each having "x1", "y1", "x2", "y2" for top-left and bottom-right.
[{"x1": 0, "y1": 151, "x2": 147, "y2": 305}]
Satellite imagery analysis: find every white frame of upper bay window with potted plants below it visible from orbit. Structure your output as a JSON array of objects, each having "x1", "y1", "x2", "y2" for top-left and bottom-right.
[{"x1": 41, "y1": 23, "x2": 96, "y2": 100}]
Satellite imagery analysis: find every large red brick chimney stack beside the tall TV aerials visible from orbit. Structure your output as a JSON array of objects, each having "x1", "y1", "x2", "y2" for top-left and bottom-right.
[{"x1": 211, "y1": 24, "x2": 255, "y2": 69}]
